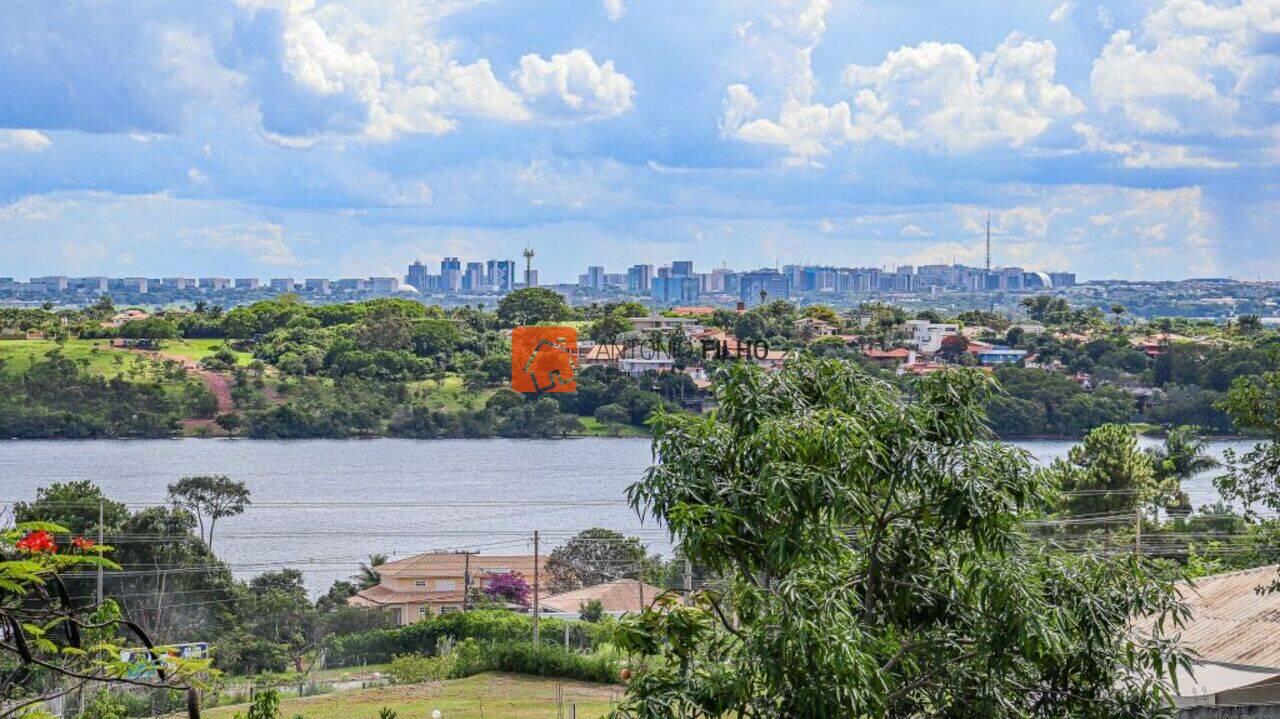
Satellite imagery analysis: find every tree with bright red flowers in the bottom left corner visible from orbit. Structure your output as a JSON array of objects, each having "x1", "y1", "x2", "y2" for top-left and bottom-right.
[{"x1": 0, "y1": 522, "x2": 207, "y2": 718}]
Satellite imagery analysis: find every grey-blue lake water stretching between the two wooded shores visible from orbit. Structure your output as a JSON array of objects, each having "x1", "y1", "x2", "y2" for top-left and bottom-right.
[{"x1": 0, "y1": 439, "x2": 1251, "y2": 592}]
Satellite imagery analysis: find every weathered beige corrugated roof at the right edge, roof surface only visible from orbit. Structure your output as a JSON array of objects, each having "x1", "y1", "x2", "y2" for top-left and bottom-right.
[{"x1": 1162, "y1": 564, "x2": 1280, "y2": 670}]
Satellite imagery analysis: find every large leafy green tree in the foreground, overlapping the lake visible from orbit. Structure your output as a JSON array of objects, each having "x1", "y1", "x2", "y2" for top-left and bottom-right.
[{"x1": 616, "y1": 357, "x2": 1187, "y2": 719}]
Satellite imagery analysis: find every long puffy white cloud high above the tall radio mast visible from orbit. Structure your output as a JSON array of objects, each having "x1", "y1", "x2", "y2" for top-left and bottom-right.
[{"x1": 721, "y1": 35, "x2": 1084, "y2": 159}]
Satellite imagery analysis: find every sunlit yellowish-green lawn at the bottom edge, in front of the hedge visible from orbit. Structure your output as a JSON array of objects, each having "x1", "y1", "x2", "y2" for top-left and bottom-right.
[{"x1": 201, "y1": 673, "x2": 623, "y2": 719}]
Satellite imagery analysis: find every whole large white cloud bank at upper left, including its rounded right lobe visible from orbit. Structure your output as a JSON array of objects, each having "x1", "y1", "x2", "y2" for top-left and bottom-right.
[{"x1": 242, "y1": 0, "x2": 634, "y2": 140}]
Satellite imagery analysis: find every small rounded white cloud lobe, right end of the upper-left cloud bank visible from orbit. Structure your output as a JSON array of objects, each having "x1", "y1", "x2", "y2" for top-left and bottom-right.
[{"x1": 512, "y1": 49, "x2": 635, "y2": 118}]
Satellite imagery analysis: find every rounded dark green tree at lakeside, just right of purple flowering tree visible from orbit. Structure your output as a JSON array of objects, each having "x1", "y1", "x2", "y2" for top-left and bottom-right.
[{"x1": 547, "y1": 527, "x2": 652, "y2": 592}]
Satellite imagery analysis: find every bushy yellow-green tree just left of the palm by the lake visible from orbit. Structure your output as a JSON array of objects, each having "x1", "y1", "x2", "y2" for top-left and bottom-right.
[{"x1": 1050, "y1": 425, "x2": 1161, "y2": 514}]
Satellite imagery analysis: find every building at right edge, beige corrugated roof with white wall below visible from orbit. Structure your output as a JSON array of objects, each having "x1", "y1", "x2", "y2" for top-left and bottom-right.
[{"x1": 1135, "y1": 564, "x2": 1280, "y2": 707}]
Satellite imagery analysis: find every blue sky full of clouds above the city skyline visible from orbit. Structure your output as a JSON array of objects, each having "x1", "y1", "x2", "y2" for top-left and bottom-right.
[{"x1": 0, "y1": 0, "x2": 1280, "y2": 283}]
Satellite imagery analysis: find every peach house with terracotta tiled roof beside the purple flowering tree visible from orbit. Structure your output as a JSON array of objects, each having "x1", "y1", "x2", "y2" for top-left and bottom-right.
[{"x1": 347, "y1": 551, "x2": 549, "y2": 626}]
